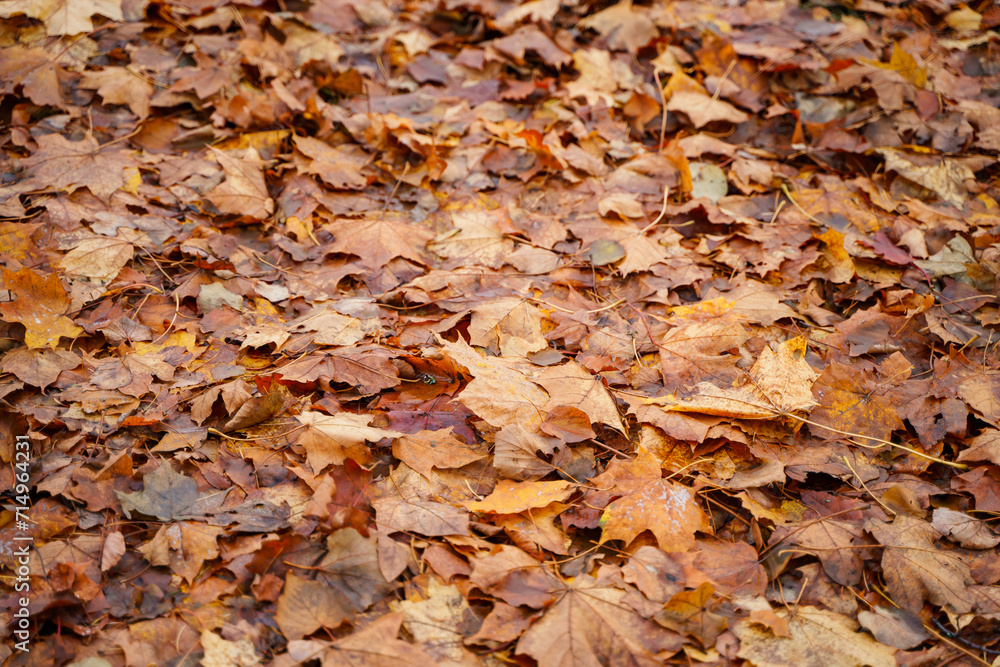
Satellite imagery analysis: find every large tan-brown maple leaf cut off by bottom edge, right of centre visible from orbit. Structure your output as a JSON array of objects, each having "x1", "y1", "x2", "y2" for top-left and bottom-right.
[{"x1": 517, "y1": 576, "x2": 681, "y2": 667}]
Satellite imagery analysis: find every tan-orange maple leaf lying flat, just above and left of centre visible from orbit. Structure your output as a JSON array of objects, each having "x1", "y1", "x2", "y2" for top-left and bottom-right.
[{"x1": 327, "y1": 213, "x2": 432, "y2": 270}]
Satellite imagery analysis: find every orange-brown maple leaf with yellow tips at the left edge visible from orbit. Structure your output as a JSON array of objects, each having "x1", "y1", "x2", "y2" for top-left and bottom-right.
[{"x1": 0, "y1": 269, "x2": 83, "y2": 350}]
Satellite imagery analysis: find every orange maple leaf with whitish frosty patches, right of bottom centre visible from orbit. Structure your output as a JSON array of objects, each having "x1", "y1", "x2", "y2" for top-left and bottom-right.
[{"x1": 593, "y1": 451, "x2": 711, "y2": 551}]
